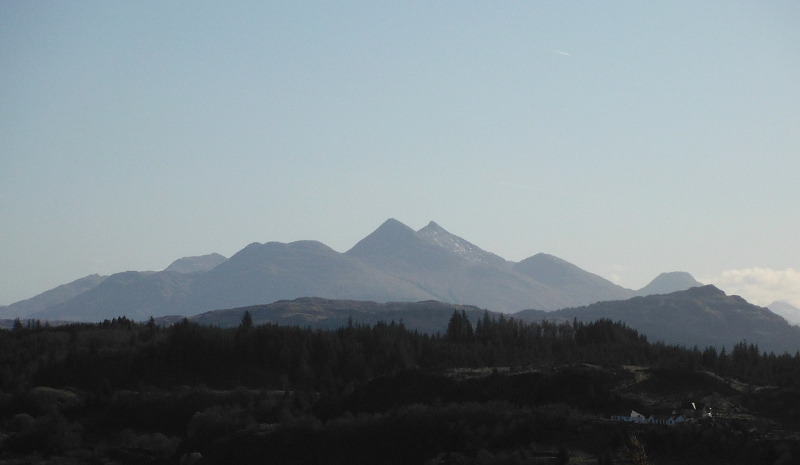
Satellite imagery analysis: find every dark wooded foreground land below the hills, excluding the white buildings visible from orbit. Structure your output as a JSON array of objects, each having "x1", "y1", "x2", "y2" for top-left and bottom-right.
[{"x1": 0, "y1": 312, "x2": 800, "y2": 464}]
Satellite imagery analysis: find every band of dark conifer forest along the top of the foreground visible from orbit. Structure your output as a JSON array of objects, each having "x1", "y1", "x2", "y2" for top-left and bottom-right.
[{"x1": 0, "y1": 312, "x2": 800, "y2": 395}]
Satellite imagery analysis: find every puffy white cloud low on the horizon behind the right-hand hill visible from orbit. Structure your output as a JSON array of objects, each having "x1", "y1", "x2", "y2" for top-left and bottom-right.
[{"x1": 700, "y1": 267, "x2": 800, "y2": 307}]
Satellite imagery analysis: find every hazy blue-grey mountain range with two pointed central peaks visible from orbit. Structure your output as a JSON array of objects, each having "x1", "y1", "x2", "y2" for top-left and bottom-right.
[{"x1": 0, "y1": 219, "x2": 700, "y2": 321}]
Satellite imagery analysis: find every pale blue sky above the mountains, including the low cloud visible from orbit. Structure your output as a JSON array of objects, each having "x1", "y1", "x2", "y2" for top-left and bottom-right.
[{"x1": 0, "y1": 1, "x2": 800, "y2": 306}]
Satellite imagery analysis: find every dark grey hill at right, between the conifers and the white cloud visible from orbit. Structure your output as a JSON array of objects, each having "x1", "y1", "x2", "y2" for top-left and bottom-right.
[{"x1": 515, "y1": 285, "x2": 800, "y2": 354}]
